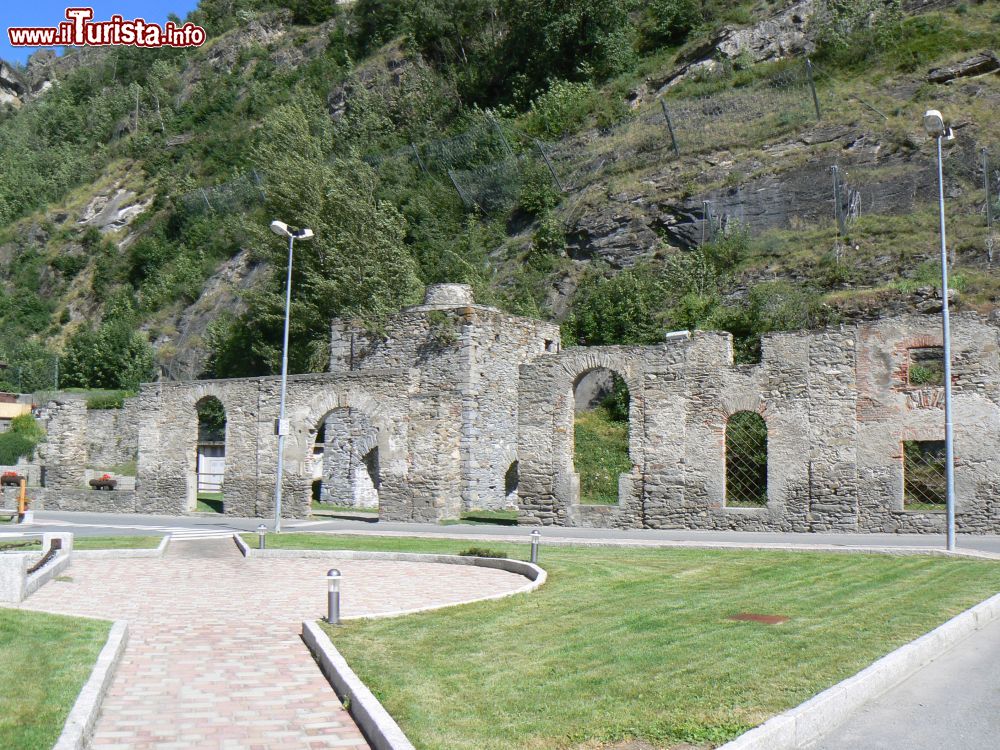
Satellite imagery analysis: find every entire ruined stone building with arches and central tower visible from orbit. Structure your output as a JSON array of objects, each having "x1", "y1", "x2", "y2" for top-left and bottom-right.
[{"x1": 27, "y1": 285, "x2": 1000, "y2": 533}]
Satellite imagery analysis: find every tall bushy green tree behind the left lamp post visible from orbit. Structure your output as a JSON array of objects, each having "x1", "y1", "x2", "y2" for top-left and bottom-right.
[{"x1": 214, "y1": 96, "x2": 420, "y2": 375}]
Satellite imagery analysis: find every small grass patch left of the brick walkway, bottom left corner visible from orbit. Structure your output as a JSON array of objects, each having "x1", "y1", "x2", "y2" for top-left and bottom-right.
[{"x1": 0, "y1": 608, "x2": 110, "y2": 750}]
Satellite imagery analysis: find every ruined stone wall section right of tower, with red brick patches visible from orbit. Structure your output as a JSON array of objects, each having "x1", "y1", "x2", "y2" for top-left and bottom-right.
[{"x1": 519, "y1": 314, "x2": 1000, "y2": 533}]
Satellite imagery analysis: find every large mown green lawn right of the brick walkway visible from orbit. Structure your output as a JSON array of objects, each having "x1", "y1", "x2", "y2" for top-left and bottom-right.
[{"x1": 254, "y1": 534, "x2": 1000, "y2": 750}]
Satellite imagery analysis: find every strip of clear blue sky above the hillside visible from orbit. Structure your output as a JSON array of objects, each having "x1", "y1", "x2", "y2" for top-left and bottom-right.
[{"x1": 0, "y1": 0, "x2": 198, "y2": 62}]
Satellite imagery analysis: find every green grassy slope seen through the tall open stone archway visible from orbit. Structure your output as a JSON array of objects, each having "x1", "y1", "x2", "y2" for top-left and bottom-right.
[{"x1": 573, "y1": 406, "x2": 632, "y2": 505}]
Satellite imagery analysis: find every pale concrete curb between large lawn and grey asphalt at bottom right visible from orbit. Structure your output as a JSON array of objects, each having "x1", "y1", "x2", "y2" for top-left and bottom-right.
[{"x1": 720, "y1": 594, "x2": 1000, "y2": 750}]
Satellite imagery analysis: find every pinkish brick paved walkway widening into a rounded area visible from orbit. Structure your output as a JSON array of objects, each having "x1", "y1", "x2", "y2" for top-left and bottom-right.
[{"x1": 23, "y1": 541, "x2": 525, "y2": 750}]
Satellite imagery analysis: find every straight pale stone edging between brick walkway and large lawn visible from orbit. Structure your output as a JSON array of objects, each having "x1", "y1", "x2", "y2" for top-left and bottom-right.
[{"x1": 302, "y1": 621, "x2": 414, "y2": 750}]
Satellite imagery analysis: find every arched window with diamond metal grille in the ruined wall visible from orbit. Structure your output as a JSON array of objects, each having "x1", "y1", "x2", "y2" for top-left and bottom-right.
[{"x1": 726, "y1": 411, "x2": 767, "y2": 507}]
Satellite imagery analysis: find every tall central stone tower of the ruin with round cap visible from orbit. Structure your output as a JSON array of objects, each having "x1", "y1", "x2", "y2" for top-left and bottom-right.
[{"x1": 330, "y1": 284, "x2": 560, "y2": 517}]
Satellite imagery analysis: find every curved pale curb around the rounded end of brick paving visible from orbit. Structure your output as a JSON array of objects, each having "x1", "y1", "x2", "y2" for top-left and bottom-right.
[{"x1": 233, "y1": 534, "x2": 548, "y2": 620}]
